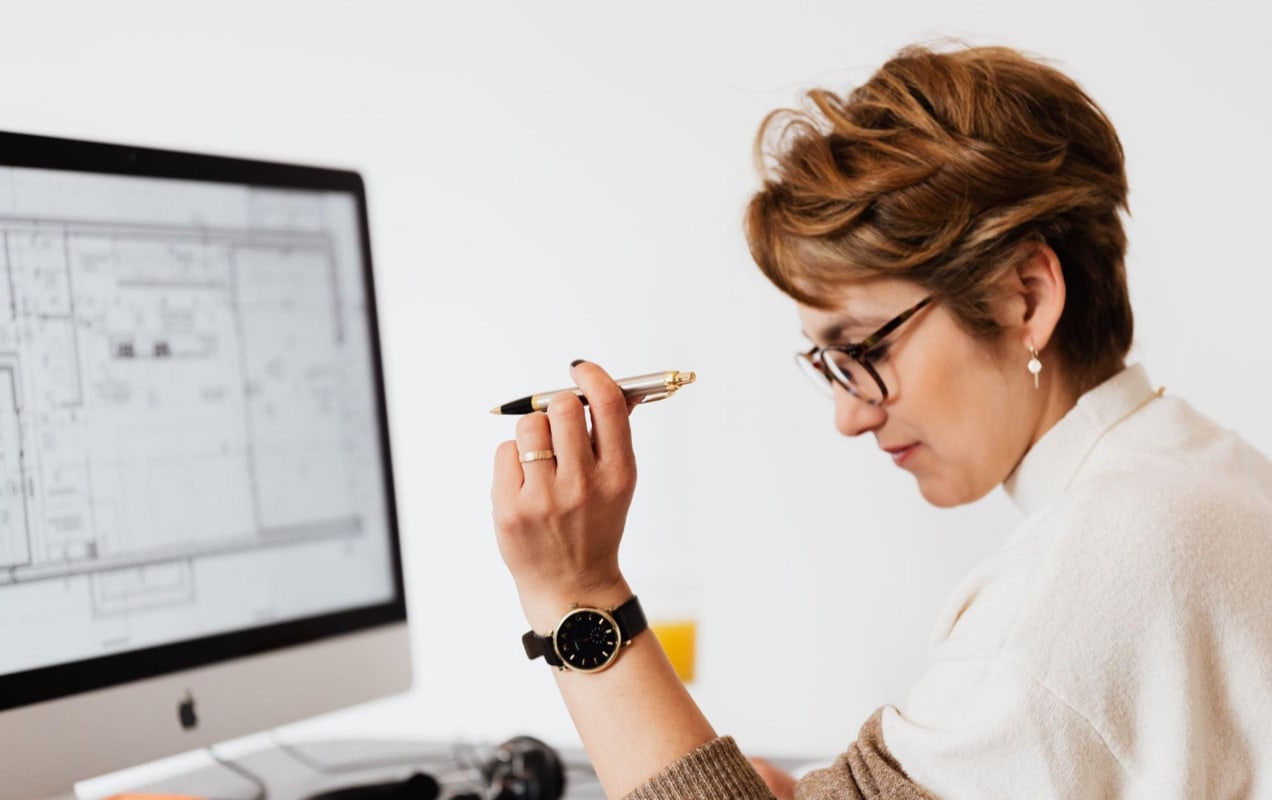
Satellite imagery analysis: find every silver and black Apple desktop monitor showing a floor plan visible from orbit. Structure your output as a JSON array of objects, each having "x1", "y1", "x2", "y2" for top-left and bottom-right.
[{"x1": 0, "y1": 134, "x2": 411, "y2": 800}]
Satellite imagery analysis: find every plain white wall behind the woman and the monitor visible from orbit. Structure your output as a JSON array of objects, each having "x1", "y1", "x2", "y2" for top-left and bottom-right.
[{"x1": 0, "y1": 0, "x2": 1272, "y2": 753}]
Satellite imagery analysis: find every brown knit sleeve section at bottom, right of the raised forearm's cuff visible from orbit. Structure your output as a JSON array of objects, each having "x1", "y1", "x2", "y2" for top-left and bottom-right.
[{"x1": 795, "y1": 708, "x2": 936, "y2": 800}]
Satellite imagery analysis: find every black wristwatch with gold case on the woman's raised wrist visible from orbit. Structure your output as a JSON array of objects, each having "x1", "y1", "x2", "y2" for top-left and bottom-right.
[{"x1": 522, "y1": 595, "x2": 649, "y2": 673}]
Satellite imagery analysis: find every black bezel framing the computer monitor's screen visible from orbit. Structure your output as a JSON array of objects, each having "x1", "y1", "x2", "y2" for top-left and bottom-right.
[{"x1": 0, "y1": 131, "x2": 407, "y2": 711}]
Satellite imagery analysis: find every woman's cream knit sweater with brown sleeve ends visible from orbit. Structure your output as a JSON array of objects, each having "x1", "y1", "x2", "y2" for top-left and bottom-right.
[{"x1": 633, "y1": 366, "x2": 1272, "y2": 800}]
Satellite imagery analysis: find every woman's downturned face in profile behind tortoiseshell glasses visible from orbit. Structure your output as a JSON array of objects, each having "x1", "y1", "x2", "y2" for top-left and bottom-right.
[{"x1": 799, "y1": 280, "x2": 1058, "y2": 506}]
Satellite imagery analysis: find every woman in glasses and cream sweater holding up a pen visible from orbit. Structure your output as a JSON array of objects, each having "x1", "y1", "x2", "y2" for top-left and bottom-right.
[{"x1": 494, "y1": 48, "x2": 1272, "y2": 799}]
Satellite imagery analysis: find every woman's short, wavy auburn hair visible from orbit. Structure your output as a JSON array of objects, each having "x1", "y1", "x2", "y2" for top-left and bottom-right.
[{"x1": 745, "y1": 47, "x2": 1133, "y2": 392}]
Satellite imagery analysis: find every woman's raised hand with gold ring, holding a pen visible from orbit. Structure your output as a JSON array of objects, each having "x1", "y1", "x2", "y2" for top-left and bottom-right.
[{"x1": 491, "y1": 361, "x2": 636, "y2": 630}]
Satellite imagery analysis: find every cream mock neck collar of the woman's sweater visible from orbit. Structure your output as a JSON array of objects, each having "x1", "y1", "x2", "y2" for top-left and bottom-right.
[{"x1": 1002, "y1": 364, "x2": 1156, "y2": 515}]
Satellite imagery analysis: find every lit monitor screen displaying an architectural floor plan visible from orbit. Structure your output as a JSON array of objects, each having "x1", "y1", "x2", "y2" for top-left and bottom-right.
[{"x1": 0, "y1": 169, "x2": 391, "y2": 674}]
